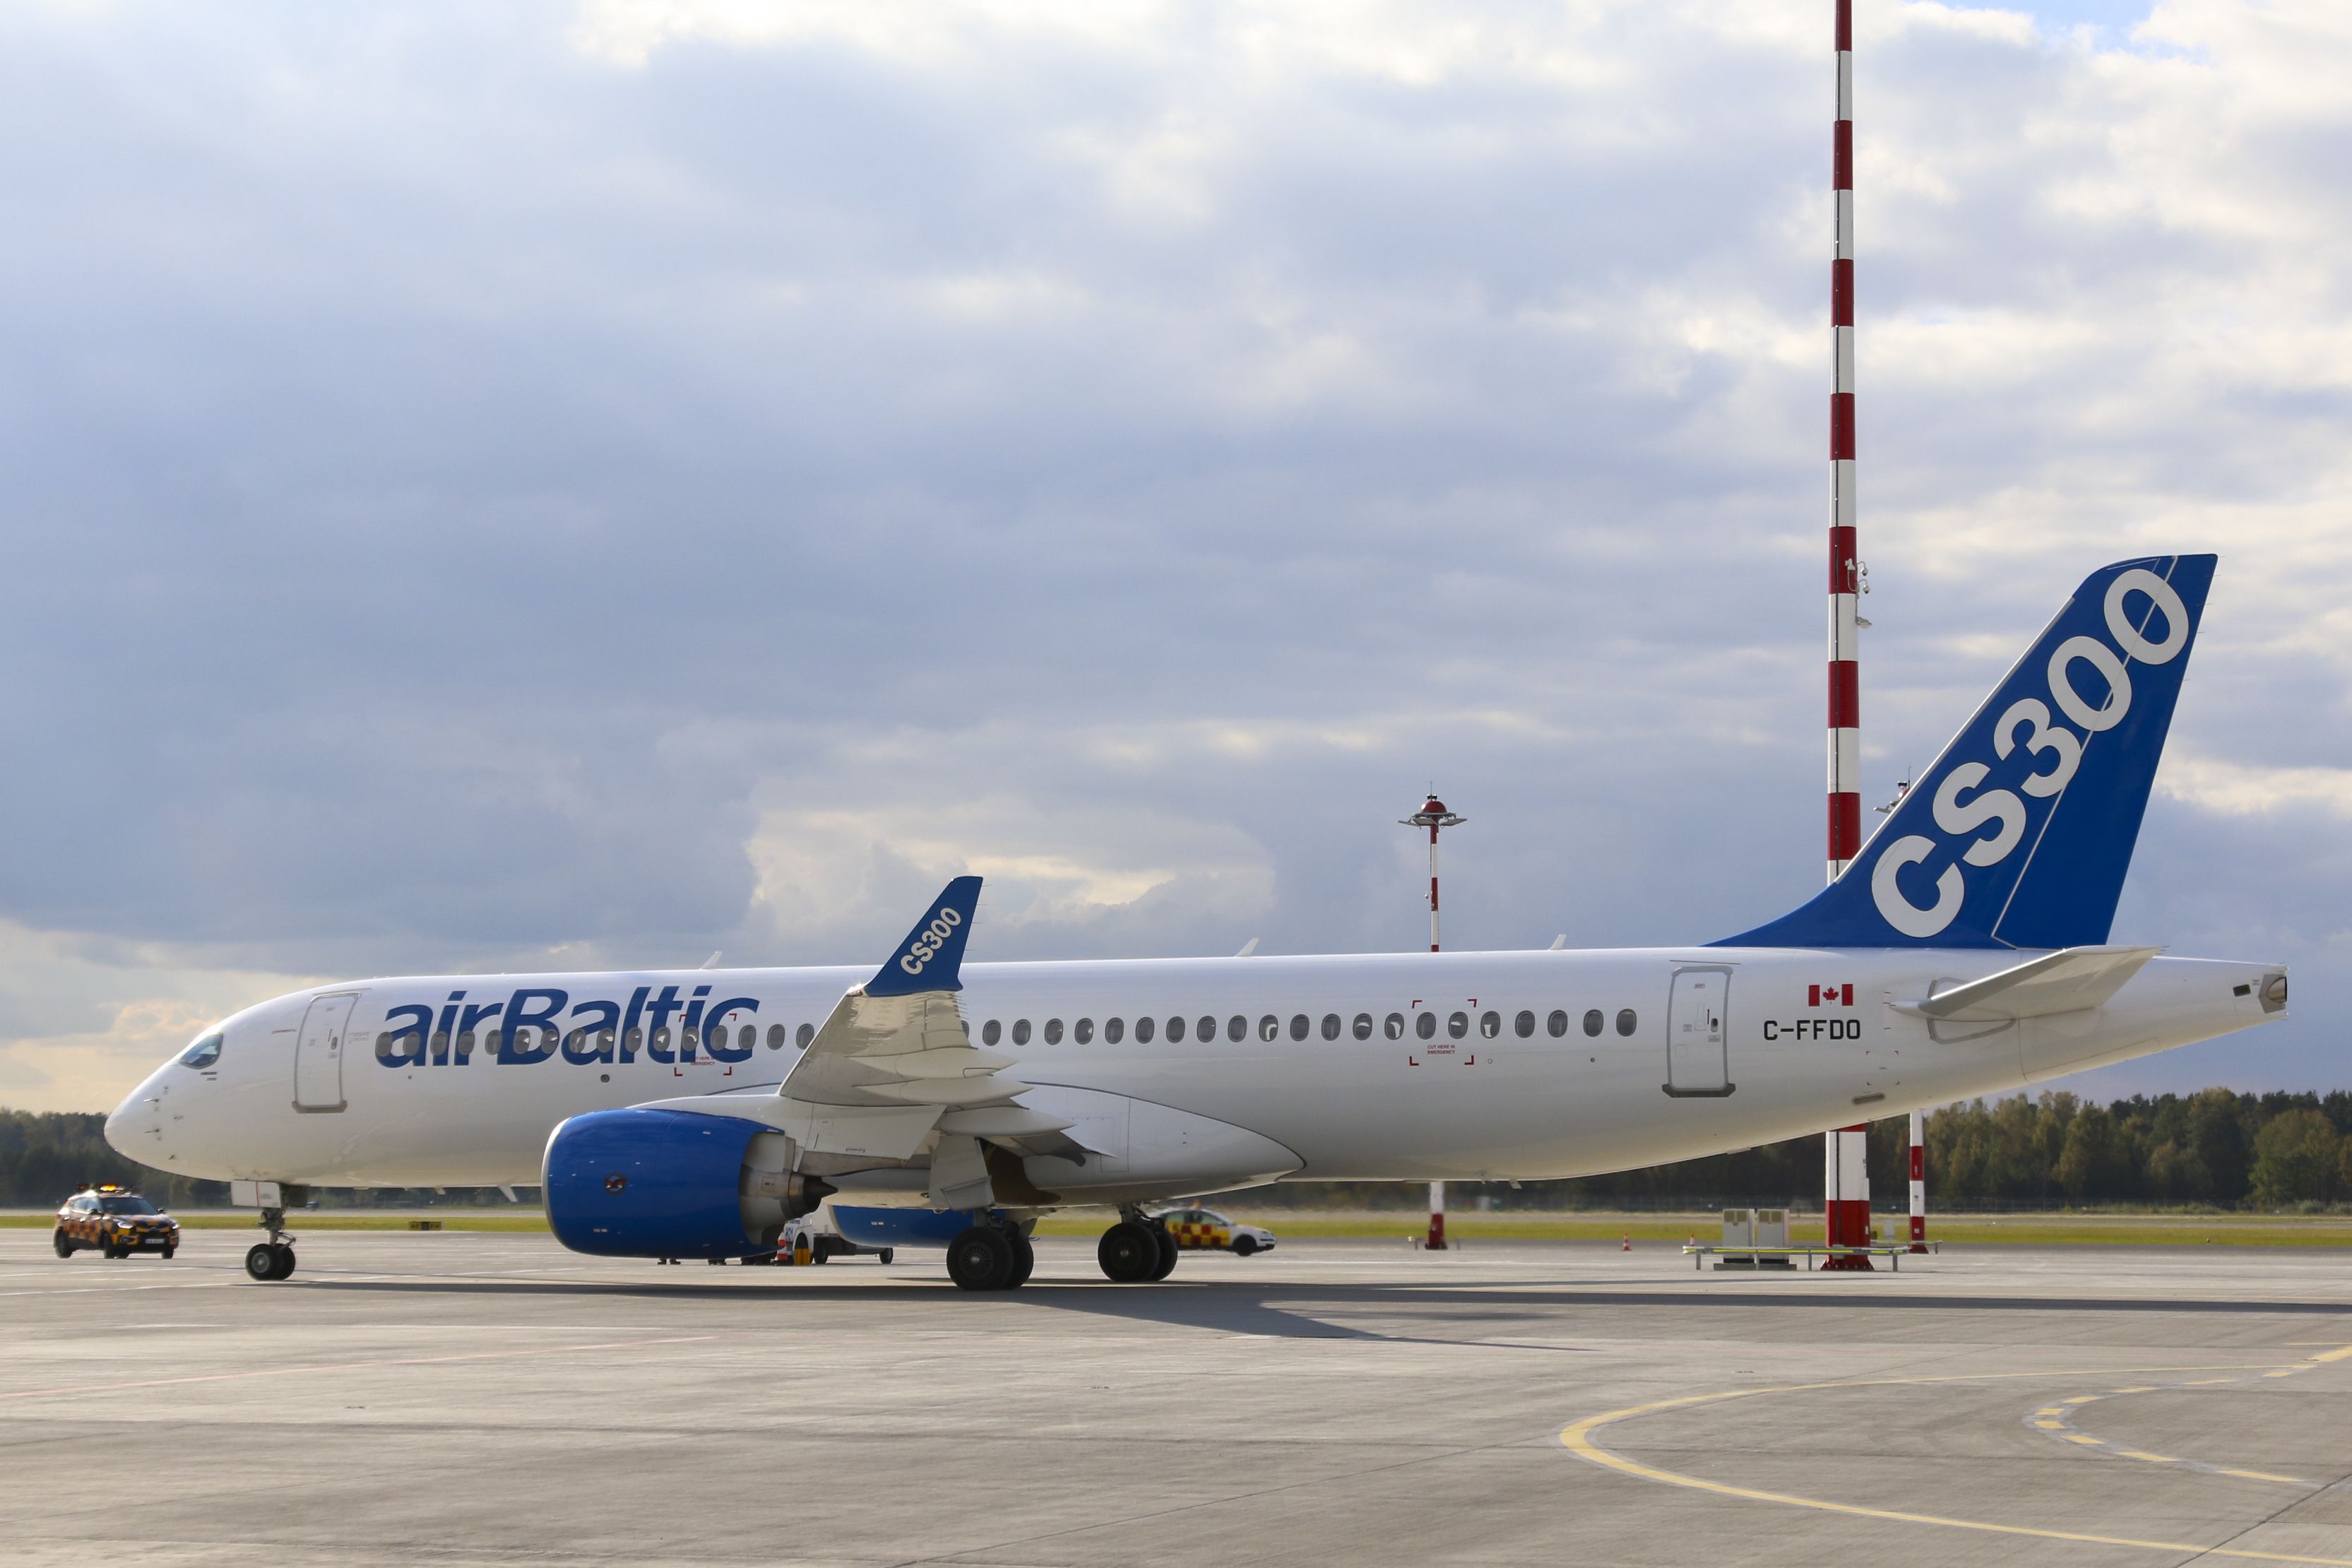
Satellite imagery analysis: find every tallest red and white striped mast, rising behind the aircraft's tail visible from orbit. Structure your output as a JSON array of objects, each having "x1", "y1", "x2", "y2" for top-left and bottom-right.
[{"x1": 1823, "y1": 0, "x2": 1870, "y2": 1269}]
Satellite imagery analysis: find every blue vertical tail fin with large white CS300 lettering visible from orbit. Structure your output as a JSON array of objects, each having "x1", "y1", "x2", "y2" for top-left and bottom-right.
[{"x1": 1717, "y1": 554, "x2": 2216, "y2": 947}]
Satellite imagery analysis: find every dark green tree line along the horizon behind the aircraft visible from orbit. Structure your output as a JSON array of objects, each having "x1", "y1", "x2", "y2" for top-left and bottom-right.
[{"x1": 13, "y1": 1088, "x2": 2352, "y2": 1211}]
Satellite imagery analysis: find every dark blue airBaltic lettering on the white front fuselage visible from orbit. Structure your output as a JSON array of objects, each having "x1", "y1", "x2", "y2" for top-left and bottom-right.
[{"x1": 376, "y1": 985, "x2": 760, "y2": 1067}]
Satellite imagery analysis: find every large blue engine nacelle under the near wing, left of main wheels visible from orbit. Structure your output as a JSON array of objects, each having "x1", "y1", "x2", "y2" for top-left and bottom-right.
[{"x1": 543, "y1": 1110, "x2": 830, "y2": 1258}]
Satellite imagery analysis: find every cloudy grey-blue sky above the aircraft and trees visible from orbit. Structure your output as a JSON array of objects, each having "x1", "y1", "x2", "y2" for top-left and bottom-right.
[{"x1": 0, "y1": 0, "x2": 2352, "y2": 1110}]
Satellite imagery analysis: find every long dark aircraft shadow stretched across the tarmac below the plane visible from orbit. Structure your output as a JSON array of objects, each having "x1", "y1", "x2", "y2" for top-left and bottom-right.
[{"x1": 278, "y1": 1272, "x2": 2352, "y2": 1349}]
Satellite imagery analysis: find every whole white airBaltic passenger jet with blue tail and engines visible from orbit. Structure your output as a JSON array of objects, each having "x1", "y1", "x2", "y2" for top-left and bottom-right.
[{"x1": 106, "y1": 554, "x2": 2286, "y2": 1290}]
